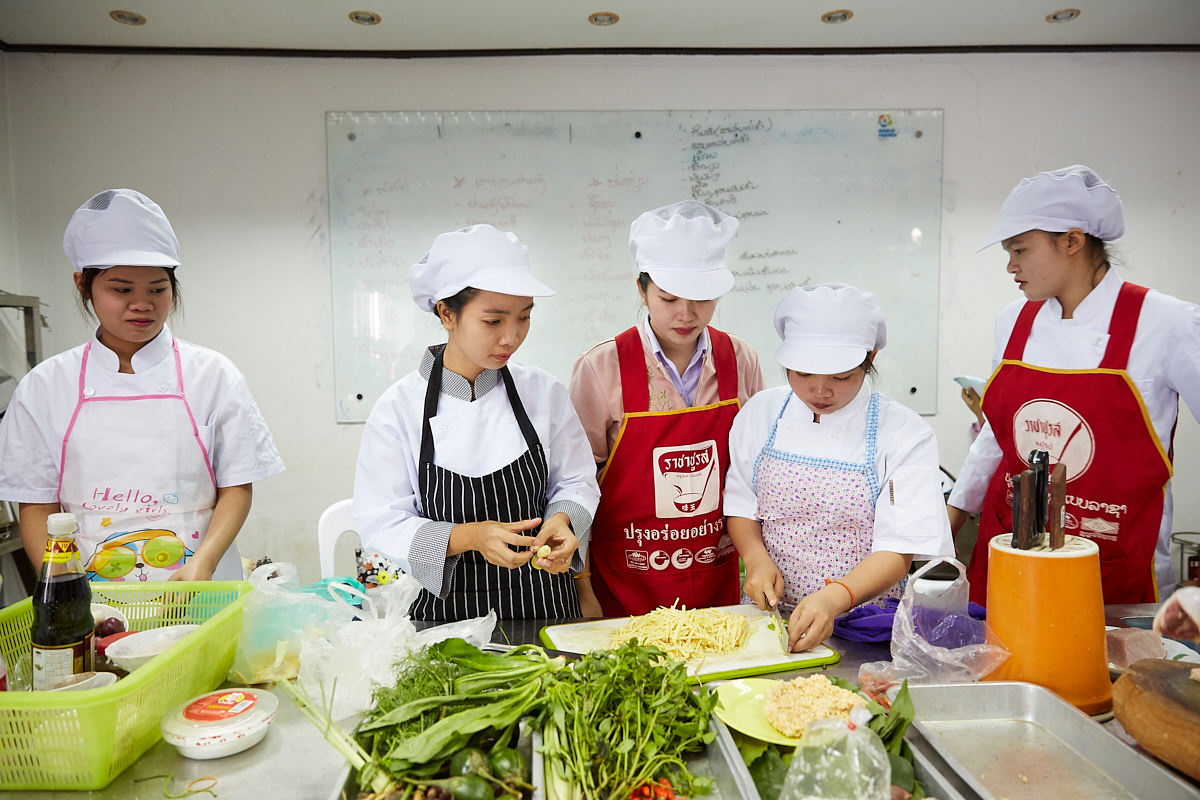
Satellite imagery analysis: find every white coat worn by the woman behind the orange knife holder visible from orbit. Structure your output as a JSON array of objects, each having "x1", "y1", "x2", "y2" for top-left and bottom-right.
[{"x1": 949, "y1": 267, "x2": 1200, "y2": 596}]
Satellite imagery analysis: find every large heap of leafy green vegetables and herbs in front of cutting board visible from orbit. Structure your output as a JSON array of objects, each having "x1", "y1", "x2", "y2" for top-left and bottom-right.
[{"x1": 280, "y1": 639, "x2": 716, "y2": 800}]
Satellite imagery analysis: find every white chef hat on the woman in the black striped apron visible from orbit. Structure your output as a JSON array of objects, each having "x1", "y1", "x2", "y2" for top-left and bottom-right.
[{"x1": 408, "y1": 225, "x2": 554, "y2": 311}]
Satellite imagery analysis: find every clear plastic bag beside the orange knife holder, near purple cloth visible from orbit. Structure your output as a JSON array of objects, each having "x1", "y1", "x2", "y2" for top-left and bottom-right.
[{"x1": 858, "y1": 559, "x2": 1010, "y2": 684}]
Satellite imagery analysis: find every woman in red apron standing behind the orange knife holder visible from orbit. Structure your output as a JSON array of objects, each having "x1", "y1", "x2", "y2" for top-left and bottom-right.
[{"x1": 949, "y1": 166, "x2": 1200, "y2": 603}]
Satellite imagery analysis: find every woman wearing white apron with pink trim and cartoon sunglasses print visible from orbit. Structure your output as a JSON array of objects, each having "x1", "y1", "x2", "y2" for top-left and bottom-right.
[{"x1": 0, "y1": 190, "x2": 283, "y2": 581}]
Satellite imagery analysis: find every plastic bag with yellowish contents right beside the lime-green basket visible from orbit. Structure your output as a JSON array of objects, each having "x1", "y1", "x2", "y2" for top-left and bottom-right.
[{"x1": 229, "y1": 563, "x2": 354, "y2": 684}]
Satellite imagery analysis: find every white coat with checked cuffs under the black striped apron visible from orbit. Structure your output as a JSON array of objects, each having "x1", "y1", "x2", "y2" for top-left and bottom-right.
[{"x1": 353, "y1": 350, "x2": 600, "y2": 596}]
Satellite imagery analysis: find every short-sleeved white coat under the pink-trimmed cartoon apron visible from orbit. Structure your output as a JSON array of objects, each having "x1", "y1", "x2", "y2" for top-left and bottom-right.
[{"x1": 0, "y1": 325, "x2": 283, "y2": 503}]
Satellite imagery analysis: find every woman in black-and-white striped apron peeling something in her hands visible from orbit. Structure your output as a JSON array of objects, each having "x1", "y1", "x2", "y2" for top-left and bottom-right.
[{"x1": 354, "y1": 224, "x2": 600, "y2": 620}]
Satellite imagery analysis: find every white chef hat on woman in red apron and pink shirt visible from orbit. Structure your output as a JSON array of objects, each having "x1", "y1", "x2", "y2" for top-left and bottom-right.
[{"x1": 629, "y1": 200, "x2": 738, "y2": 300}]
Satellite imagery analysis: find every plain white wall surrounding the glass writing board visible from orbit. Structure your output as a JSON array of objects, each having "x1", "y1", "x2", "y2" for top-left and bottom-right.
[{"x1": 0, "y1": 53, "x2": 1200, "y2": 578}]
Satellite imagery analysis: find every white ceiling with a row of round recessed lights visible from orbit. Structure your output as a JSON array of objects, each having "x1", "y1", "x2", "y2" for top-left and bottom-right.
[{"x1": 0, "y1": 0, "x2": 1200, "y2": 55}]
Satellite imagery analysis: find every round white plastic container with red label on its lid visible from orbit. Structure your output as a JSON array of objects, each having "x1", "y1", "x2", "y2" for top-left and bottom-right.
[{"x1": 162, "y1": 688, "x2": 280, "y2": 760}]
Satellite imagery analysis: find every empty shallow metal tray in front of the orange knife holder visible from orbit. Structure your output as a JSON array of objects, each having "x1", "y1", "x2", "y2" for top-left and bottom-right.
[{"x1": 908, "y1": 681, "x2": 1200, "y2": 800}]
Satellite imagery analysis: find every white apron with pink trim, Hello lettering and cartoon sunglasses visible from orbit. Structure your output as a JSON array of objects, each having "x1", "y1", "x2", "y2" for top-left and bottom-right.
[{"x1": 59, "y1": 339, "x2": 242, "y2": 581}]
